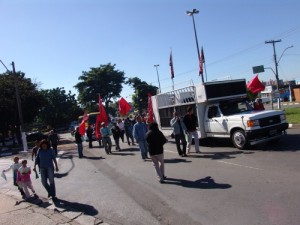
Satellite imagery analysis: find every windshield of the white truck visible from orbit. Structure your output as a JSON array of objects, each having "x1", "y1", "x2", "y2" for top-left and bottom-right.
[{"x1": 220, "y1": 99, "x2": 253, "y2": 116}]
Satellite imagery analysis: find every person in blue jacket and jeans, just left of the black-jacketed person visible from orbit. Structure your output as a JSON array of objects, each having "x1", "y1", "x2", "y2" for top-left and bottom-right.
[{"x1": 132, "y1": 116, "x2": 148, "y2": 161}]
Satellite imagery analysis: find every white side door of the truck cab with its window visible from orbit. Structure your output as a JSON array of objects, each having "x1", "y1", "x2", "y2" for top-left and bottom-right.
[{"x1": 205, "y1": 105, "x2": 228, "y2": 137}]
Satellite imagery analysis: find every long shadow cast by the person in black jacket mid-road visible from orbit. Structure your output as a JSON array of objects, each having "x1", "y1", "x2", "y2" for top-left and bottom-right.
[{"x1": 165, "y1": 177, "x2": 232, "y2": 189}]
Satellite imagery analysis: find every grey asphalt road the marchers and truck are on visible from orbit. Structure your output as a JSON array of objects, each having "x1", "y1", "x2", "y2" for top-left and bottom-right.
[{"x1": 0, "y1": 129, "x2": 300, "y2": 225}]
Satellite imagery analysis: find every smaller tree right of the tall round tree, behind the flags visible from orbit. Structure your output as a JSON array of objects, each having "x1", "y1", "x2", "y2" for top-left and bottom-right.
[{"x1": 125, "y1": 77, "x2": 158, "y2": 113}]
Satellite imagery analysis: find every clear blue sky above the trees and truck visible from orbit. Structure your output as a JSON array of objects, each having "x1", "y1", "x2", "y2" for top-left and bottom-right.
[{"x1": 0, "y1": 0, "x2": 300, "y2": 100}]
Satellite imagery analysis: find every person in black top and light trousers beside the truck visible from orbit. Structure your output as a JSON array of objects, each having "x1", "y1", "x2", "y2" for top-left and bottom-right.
[{"x1": 183, "y1": 106, "x2": 200, "y2": 153}]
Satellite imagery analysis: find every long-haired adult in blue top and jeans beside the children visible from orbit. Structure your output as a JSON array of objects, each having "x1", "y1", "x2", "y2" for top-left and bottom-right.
[{"x1": 33, "y1": 139, "x2": 58, "y2": 201}]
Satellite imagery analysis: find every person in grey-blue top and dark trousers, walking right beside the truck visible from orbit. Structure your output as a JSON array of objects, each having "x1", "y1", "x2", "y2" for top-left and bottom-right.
[{"x1": 170, "y1": 112, "x2": 187, "y2": 157}]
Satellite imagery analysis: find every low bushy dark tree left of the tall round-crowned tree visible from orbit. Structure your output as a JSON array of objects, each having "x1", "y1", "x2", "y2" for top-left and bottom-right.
[{"x1": 38, "y1": 88, "x2": 83, "y2": 128}]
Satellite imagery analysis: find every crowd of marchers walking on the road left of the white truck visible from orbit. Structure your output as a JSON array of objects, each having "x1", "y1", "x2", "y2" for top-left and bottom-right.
[{"x1": 75, "y1": 107, "x2": 200, "y2": 183}]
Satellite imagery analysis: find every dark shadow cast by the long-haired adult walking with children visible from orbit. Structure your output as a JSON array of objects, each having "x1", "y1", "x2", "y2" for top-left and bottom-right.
[{"x1": 53, "y1": 199, "x2": 98, "y2": 216}]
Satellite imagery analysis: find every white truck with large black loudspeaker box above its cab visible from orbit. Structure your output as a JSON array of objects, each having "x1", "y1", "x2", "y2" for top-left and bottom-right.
[{"x1": 152, "y1": 79, "x2": 288, "y2": 149}]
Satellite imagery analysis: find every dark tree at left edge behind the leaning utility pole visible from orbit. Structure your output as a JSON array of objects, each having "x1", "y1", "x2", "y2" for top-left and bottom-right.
[{"x1": 0, "y1": 72, "x2": 44, "y2": 130}]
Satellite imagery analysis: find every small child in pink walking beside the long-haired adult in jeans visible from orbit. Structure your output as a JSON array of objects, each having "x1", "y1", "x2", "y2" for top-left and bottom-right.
[{"x1": 17, "y1": 159, "x2": 36, "y2": 199}]
